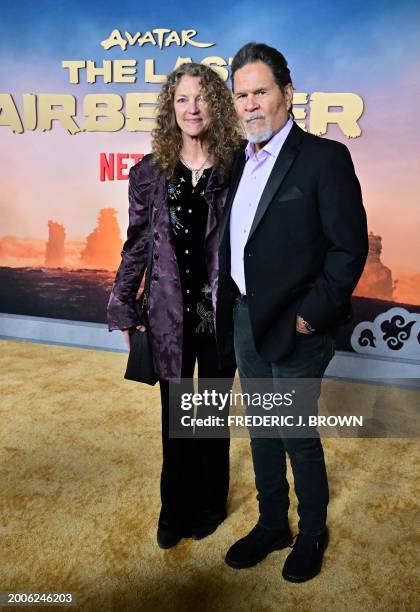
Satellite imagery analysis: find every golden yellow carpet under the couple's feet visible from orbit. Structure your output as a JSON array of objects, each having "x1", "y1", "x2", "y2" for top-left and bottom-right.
[{"x1": 0, "y1": 340, "x2": 420, "y2": 612}]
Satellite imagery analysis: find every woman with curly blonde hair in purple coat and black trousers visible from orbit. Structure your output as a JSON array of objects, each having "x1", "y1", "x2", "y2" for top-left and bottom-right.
[{"x1": 108, "y1": 63, "x2": 241, "y2": 548}]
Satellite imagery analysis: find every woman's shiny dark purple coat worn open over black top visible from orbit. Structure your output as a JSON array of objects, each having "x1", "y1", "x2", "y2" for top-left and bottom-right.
[{"x1": 107, "y1": 155, "x2": 228, "y2": 380}]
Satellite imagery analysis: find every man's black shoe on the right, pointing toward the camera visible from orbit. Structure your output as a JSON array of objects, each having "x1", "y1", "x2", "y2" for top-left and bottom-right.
[{"x1": 282, "y1": 529, "x2": 328, "y2": 582}]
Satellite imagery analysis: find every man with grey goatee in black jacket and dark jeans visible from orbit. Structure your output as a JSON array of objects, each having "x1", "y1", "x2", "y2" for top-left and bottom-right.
[{"x1": 216, "y1": 43, "x2": 368, "y2": 582}]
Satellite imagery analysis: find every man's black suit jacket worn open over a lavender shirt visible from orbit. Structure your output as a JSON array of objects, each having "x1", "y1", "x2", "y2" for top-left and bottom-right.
[{"x1": 216, "y1": 124, "x2": 368, "y2": 361}]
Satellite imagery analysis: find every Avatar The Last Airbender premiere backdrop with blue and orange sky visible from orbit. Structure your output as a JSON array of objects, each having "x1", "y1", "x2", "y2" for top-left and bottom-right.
[{"x1": 0, "y1": 0, "x2": 420, "y2": 377}]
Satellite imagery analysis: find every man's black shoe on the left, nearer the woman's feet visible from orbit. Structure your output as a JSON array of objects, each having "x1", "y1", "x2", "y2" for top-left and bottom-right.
[{"x1": 225, "y1": 524, "x2": 293, "y2": 569}]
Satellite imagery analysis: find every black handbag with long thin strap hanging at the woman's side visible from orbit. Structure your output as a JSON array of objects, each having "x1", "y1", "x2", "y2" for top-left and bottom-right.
[{"x1": 124, "y1": 205, "x2": 158, "y2": 385}]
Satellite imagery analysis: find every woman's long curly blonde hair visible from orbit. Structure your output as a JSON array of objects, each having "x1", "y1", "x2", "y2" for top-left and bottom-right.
[{"x1": 152, "y1": 63, "x2": 243, "y2": 178}]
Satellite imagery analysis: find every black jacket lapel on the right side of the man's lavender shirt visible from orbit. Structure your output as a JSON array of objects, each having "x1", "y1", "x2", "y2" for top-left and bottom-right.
[{"x1": 248, "y1": 123, "x2": 305, "y2": 241}]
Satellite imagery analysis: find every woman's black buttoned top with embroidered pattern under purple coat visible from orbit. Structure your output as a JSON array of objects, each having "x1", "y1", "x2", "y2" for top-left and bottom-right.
[{"x1": 168, "y1": 162, "x2": 214, "y2": 334}]
